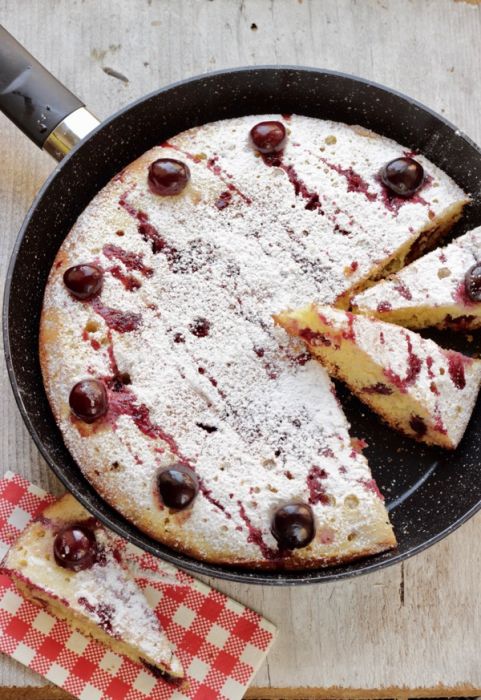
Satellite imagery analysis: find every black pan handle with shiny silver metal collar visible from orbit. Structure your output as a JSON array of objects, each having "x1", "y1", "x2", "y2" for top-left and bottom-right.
[{"x1": 0, "y1": 25, "x2": 100, "y2": 160}]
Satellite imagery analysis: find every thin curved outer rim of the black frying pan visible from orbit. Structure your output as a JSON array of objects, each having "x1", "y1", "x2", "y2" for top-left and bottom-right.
[{"x1": 2, "y1": 64, "x2": 481, "y2": 586}]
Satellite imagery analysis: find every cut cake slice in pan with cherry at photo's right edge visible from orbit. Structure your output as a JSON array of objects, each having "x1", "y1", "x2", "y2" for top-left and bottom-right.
[{"x1": 352, "y1": 226, "x2": 481, "y2": 330}]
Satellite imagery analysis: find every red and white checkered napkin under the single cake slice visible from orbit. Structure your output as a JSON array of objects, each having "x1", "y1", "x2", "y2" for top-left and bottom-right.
[{"x1": 0, "y1": 472, "x2": 276, "y2": 700}]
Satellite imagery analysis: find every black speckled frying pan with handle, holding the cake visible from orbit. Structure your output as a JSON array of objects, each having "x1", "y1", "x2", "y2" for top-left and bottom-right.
[{"x1": 0, "y1": 28, "x2": 481, "y2": 585}]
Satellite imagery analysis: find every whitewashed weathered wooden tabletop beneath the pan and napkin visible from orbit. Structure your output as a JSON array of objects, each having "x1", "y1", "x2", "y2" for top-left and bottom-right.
[{"x1": 0, "y1": 0, "x2": 481, "y2": 700}]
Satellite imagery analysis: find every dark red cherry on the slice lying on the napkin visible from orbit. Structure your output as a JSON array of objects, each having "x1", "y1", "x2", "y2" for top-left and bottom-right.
[{"x1": 53, "y1": 524, "x2": 98, "y2": 571}]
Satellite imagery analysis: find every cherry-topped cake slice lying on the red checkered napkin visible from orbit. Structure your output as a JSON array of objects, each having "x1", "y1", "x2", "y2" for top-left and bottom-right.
[{"x1": 2, "y1": 494, "x2": 184, "y2": 678}]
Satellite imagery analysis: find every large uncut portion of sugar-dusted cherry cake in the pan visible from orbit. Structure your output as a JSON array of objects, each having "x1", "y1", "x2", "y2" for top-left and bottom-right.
[{"x1": 40, "y1": 115, "x2": 469, "y2": 569}]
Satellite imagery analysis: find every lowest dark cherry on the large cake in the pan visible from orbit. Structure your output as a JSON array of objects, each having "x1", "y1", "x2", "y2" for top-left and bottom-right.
[{"x1": 271, "y1": 503, "x2": 315, "y2": 549}]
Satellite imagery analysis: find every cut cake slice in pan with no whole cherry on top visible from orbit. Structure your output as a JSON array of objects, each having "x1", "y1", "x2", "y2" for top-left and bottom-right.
[{"x1": 275, "y1": 304, "x2": 481, "y2": 449}]
